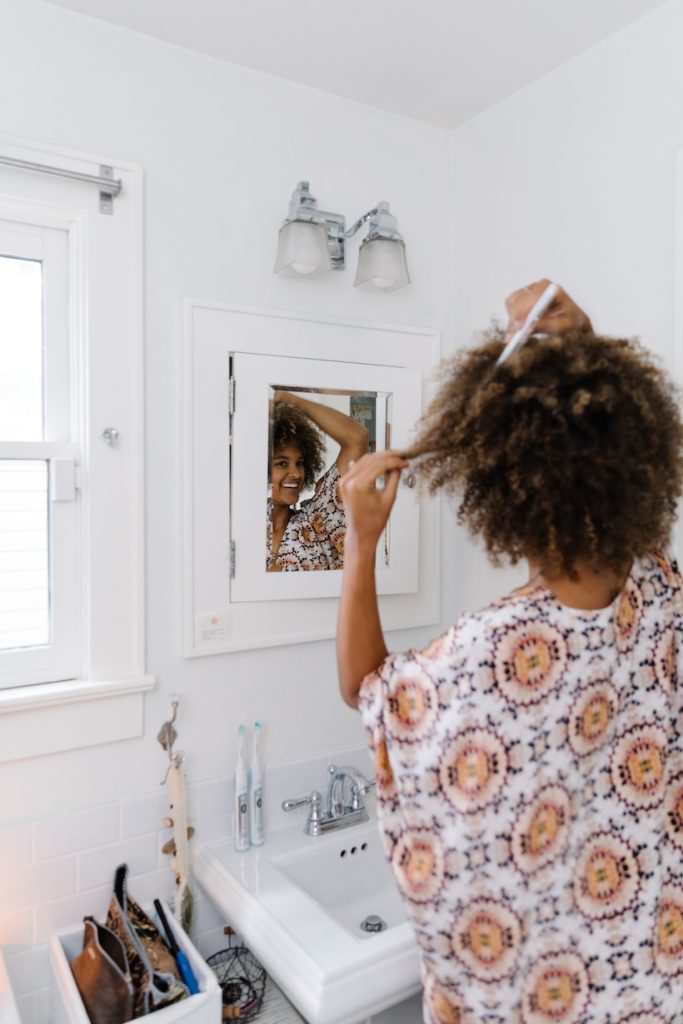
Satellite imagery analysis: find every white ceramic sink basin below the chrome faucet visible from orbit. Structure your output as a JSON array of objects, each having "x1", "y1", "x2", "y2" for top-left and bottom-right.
[{"x1": 195, "y1": 806, "x2": 420, "y2": 1024}]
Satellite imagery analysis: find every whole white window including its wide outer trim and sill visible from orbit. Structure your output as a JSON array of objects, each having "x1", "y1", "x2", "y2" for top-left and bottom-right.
[{"x1": 0, "y1": 138, "x2": 154, "y2": 761}]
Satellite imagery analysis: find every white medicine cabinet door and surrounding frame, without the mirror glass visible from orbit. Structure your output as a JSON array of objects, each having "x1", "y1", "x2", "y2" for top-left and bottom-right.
[{"x1": 182, "y1": 299, "x2": 439, "y2": 657}]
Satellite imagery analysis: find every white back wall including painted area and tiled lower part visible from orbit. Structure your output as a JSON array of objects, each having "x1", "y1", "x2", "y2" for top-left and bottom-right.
[{"x1": 0, "y1": 6, "x2": 451, "y2": 1024}]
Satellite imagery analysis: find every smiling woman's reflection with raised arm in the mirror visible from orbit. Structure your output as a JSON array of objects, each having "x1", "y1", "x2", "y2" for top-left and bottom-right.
[{"x1": 266, "y1": 391, "x2": 368, "y2": 572}]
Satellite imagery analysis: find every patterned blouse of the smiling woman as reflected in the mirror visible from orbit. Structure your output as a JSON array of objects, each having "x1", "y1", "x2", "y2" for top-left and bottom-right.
[{"x1": 265, "y1": 464, "x2": 346, "y2": 572}]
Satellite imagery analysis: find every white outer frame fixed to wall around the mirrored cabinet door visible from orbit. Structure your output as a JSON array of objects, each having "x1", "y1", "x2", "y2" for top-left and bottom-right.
[{"x1": 181, "y1": 299, "x2": 439, "y2": 657}]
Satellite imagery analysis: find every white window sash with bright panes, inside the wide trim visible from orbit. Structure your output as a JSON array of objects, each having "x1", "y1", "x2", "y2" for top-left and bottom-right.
[{"x1": 0, "y1": 220, "x2": 79, "y2": 687}]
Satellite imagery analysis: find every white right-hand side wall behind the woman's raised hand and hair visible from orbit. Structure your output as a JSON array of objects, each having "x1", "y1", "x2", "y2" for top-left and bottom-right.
[{"x1": 453, "y1": 0, "x2": 683, "y2": 605}]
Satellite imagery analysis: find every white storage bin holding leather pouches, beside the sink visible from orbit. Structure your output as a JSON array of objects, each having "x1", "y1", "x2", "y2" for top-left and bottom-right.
[{"x1": 50, "y1": 903, "x2": 221, "y2": 1024}]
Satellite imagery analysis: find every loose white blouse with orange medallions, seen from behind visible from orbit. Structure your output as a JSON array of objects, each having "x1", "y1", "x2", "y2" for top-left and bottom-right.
[{"x1": 360, "y1": 556, "x2": 683, "y2": 1024}]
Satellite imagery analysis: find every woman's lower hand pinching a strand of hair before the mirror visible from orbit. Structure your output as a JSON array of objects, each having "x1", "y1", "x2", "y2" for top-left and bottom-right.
[{"x1": 339, "y1": 452, "x2": 409, "y2": 550}]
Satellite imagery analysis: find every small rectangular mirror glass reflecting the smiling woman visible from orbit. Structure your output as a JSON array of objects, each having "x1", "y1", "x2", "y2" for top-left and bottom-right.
[{"x1": 265, "y1": 384, "x2": 391, "y2": 572}]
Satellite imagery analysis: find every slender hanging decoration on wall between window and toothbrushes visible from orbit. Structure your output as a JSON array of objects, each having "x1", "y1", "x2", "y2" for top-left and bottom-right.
[{"x1": 157, "y1": 696, "x2": 195, "y2": 932}]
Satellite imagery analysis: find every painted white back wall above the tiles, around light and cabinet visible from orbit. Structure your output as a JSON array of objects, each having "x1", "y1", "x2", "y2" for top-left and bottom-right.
[{"x1": 0, "y1": 0, "x2": 450, "y2": 818}]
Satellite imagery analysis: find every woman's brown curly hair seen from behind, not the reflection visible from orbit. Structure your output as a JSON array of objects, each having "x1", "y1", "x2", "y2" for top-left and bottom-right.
[{"x1": 409, "y1": 331, "x2": 683, "y2": 578}]
